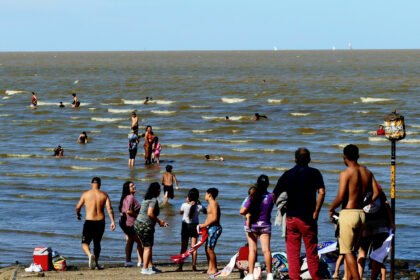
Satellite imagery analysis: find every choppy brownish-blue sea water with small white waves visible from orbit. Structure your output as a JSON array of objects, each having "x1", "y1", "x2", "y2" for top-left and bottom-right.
[{"x1": 0, "y1": 51, "x2": 420, "y2": 266}]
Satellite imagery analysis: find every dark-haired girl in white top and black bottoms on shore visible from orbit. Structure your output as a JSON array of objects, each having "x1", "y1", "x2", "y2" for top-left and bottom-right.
[{"x1": 176, "y1": 188, "x2": 207, "y2": 271}]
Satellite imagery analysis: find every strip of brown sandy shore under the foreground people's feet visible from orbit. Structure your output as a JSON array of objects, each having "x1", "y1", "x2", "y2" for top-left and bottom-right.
[{"x1": 0, "y1": 259, "x2": 420, "y2": 280}]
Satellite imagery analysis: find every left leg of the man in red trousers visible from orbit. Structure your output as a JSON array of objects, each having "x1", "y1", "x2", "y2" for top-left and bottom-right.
[{"x1": 286, "y1": 217, "x2": 302, "y2": 279}]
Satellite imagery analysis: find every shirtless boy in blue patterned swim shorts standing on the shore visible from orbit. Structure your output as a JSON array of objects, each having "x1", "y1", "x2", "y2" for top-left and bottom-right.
[{"x1": 199, "y1": 188, "x2": 222, "y2": 274}]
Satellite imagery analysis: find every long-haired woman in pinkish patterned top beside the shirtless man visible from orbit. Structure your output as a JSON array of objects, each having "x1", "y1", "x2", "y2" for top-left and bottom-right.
[{"x1": 119, "y1": 181, "x2": 143, "y2": 267}]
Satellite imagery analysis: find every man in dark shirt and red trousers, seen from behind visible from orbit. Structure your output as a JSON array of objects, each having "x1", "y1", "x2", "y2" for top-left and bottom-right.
[{"x1": 273, "y1": 148, "x2": 325, "y2": 279}]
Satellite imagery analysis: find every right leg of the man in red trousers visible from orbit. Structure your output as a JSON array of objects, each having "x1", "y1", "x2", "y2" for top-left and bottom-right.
[{"x1": 300, "y1": 221, "x2": 321, "y2": 280}]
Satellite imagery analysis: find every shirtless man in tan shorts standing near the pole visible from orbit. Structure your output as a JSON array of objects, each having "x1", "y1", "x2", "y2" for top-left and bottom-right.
[{"x1": 330, "y1": 144, "x2": 379, "y2": 280}]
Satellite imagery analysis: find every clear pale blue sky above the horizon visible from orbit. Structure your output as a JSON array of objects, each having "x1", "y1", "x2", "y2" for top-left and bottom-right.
[{"x1": 0, "y1": 0, "x2": 420, "y2": 51}]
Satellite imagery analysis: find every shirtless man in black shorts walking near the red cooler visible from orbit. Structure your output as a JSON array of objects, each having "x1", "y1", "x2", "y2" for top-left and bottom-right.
[{"x1": 76, "y1": 177, "x2": 115, "y2": 269}]
